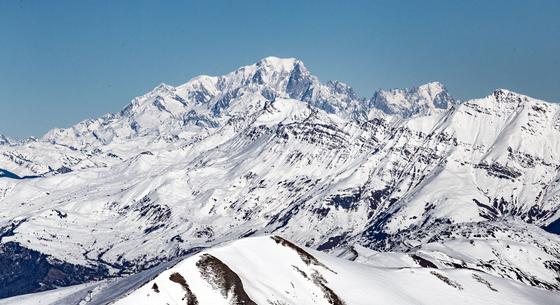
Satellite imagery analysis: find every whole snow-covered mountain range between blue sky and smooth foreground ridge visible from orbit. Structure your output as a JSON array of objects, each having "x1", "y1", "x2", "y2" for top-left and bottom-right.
[{"x1": 0, "y1": 58, "x2": 560, "y2": 297}]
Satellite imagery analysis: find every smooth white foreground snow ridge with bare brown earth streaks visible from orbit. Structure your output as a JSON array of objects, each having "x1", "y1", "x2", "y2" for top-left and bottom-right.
[{"x1": 0, "y1": 236, "x2": 560, "y2": 305}]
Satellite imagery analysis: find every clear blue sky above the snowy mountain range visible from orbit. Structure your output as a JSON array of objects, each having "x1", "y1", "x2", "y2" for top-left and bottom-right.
[{"x1": 0, "y1": 0, "x2": 560, "y2": 138}]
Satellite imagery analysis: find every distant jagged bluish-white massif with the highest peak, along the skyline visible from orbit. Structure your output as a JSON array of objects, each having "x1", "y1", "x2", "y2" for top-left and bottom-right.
[{"x1": 39, "y1": 57, "x2": 457, "y2": 148}]
